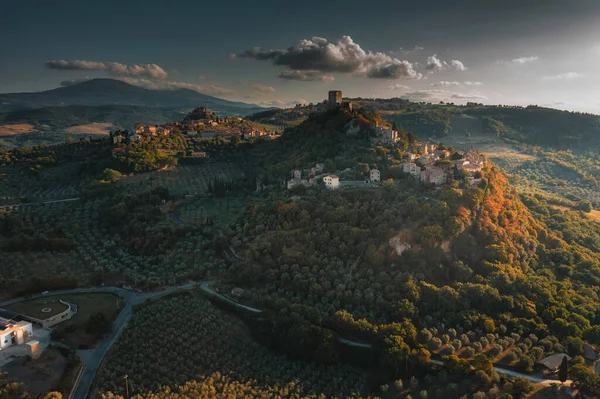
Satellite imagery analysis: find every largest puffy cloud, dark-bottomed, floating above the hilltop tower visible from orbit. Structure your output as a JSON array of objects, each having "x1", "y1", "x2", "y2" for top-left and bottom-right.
[{"x1": 231, "y1": 36, "x2": 422, "y2": 80}]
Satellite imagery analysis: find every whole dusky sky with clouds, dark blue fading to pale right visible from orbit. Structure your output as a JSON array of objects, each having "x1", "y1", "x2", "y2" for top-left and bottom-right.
[{"x1": 0, "y1": 0, "x2": 600, "y2": 114}]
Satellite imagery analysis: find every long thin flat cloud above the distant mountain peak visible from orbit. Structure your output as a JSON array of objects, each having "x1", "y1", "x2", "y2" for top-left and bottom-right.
[{"x1": 44, "y1": 60, "x2": 168, "y2": 80}]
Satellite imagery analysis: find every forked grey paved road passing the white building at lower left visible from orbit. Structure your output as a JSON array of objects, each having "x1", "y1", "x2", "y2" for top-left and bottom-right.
[{"x1": 0, "y1": 283, "x2": 196, "y2": 399}]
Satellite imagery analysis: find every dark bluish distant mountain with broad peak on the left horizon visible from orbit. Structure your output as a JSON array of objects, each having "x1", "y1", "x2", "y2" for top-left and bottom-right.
[{"x1": 0, "y1": 79, "x2": 264, "y2": 115}]
